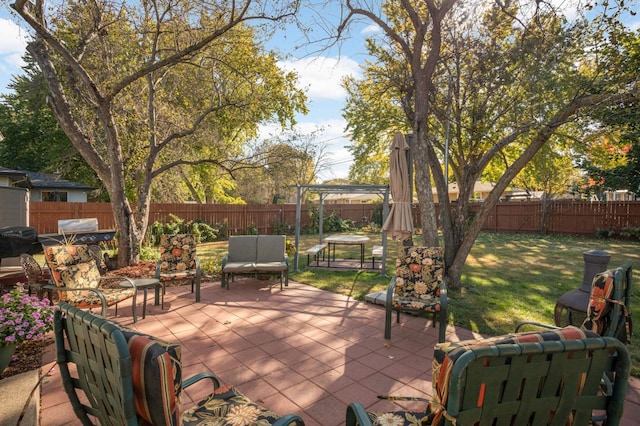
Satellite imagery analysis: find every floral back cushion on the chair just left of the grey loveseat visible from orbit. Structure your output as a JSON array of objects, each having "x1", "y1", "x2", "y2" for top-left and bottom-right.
[{"x1": 159, "y1": 234, "x2": 196, "y2": 281}]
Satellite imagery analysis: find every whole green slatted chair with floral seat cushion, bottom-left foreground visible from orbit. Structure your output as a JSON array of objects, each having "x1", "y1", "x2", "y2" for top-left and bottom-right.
[{"x1": 54, "y1": 303, "x2": 304, "y2": 426}]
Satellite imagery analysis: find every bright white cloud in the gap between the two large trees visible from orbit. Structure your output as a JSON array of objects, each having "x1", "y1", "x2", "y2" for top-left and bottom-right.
[{"x1": 280, "y1": 56, "x2": 359, "y2": 100}]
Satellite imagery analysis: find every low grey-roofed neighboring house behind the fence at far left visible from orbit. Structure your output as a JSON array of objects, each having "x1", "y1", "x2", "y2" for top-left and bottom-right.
[{"x1": 0, "y1": 167, "x2": 95, "y2": 203}]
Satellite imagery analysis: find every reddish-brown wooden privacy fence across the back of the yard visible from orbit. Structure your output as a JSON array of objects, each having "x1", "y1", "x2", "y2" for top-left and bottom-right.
[{"x1": 29, "y1": 201, "x2": 640, "y2": 236}]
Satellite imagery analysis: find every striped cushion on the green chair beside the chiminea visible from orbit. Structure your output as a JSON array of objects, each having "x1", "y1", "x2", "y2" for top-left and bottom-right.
[{"x1": 582, "y1": 269, "x2": 616, "y2": 335}]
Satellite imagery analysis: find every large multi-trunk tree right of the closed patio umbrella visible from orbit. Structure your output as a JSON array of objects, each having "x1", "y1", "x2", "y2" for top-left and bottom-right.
[{"x1": 336, "y1": 0, "x2": 638, "y2": 289}]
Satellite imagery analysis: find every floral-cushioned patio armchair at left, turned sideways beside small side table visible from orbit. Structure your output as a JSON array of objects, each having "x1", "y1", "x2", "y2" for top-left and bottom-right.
[{"x1": 44, "y1": 245, "x2": 137, "y2": 322}]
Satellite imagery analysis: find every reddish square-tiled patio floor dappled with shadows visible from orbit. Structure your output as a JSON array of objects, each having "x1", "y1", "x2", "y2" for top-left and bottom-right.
[{"x1": 40, "y1": 279, "x2": 640, "y2": 426}]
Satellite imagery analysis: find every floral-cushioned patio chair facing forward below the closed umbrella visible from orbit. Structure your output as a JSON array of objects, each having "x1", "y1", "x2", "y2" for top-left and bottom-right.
[{"x1": 384, "y1": 246, "x2": 448, "y2": 342}]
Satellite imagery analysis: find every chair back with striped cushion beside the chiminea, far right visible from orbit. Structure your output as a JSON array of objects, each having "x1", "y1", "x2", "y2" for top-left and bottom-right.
[{"x1": 582, "y1": 263, "x2": 633, "y2": 343}]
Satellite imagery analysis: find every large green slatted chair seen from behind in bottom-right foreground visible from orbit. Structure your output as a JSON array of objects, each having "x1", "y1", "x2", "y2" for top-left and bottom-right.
[{"x1": 346, "y1": 326, "x2": 630, "y2": 426}]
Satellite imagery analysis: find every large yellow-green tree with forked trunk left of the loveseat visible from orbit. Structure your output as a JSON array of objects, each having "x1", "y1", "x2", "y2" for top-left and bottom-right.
[{"x1": 11, "y1": 0, "x2": 305, "y2": 266}]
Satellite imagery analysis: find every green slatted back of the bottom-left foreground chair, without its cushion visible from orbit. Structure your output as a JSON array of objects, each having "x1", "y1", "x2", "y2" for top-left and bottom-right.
[{"x1": 54, "y1": 303, "x2": 138, "y2": 426}]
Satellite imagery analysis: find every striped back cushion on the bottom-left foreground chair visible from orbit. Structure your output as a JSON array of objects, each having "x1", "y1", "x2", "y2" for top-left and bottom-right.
[{"x1": 122, "y1": 329, "x2": 182, "y2": 425}]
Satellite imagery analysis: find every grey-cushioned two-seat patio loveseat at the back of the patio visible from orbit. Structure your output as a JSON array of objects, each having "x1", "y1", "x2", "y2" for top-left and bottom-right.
[{"x1": 221, "y1": 235, "x2": 289, "y2": 290}]
